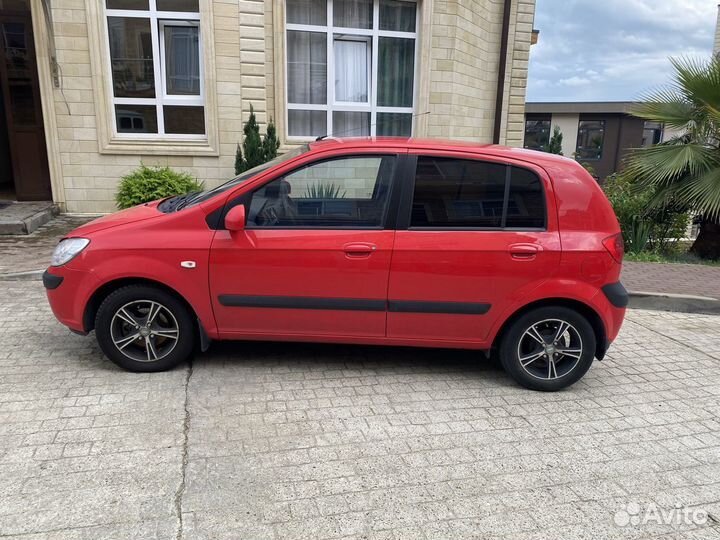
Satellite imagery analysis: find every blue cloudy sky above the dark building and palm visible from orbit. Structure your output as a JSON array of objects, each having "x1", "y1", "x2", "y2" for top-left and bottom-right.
[{"x1": 527, "y1": 0, "x2": 718, "y2": 101}]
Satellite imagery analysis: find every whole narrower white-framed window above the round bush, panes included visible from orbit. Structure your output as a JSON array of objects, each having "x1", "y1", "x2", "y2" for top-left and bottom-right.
[{"x1": 105, "y1": 0, "x2": 205, "y2": 139}]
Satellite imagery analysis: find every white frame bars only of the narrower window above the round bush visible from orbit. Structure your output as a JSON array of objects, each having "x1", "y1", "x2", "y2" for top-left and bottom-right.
[{"x1": 102, "y1": 0, "x2": 208, "y2": 141}]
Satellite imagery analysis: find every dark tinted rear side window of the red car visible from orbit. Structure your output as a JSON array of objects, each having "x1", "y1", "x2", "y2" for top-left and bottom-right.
[{"x1": 410, "y1": 156, "x2": 545, "y2": 229}]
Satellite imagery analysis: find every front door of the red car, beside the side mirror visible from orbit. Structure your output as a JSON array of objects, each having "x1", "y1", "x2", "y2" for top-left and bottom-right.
[{"x1": 210, "y1": 153, "x2": 398, "y2": 338}]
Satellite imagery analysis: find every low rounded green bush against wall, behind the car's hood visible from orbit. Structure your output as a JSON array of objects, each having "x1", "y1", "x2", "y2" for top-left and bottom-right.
[{"x1": 115, "y1": 165, "x2": 203, "y2": 209}]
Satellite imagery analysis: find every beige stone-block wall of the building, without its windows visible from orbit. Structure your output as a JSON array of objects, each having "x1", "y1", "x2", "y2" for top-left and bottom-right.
[{"x1": 38, "y1": 0, "x2": 535, "y2": 213}]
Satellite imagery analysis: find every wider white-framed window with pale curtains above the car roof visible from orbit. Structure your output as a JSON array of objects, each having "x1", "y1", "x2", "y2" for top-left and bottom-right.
[{"x1": 285, "y1": 0, "x2": 418, "y2": 139}]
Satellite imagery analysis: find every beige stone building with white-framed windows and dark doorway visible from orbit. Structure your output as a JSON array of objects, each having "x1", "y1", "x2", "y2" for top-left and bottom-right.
[{"x1": 0, "y1": 0, "x2": 535, "y2": 213}]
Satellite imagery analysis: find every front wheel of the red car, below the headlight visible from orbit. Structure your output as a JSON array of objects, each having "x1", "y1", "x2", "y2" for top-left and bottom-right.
[{"x1": 95, "y1": 285, "x2": 195, "y2": 372}]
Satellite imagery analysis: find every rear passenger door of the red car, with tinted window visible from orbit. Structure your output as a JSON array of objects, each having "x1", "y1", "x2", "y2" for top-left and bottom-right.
[{"x1": 387, "y1": 152, "x2": 560, "y2": 344}]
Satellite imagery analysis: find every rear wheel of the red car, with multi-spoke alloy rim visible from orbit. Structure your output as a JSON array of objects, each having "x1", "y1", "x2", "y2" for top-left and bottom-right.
[{"x1": 500, "y1": 306, "x2": 596, "y2": 392}]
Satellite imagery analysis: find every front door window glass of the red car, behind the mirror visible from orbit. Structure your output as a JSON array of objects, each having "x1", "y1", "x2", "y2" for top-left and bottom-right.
[{"x1": 246, "y1": 156, "x2": 395, "y2": 228}]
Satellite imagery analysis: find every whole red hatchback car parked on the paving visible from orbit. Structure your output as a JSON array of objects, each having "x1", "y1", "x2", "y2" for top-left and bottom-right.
[{"x1": 43, "y1": 139, "x2": 628, "y2": 390}]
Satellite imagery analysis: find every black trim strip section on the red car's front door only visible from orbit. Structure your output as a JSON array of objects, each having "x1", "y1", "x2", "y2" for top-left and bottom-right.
[{"x1": 218, "y1": 294, "x2": 385, "y2": 311}]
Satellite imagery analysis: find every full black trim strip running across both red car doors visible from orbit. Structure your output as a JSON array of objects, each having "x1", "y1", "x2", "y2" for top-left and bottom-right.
[{"x1": 218, "y1": 294, "x2": 491, "y2": 315}]
